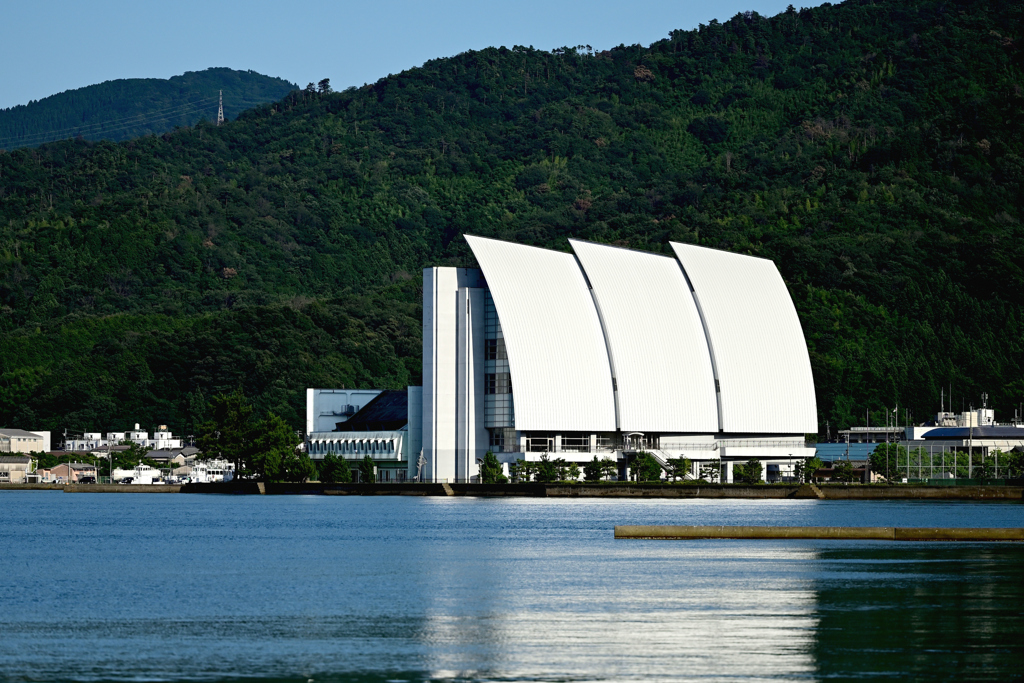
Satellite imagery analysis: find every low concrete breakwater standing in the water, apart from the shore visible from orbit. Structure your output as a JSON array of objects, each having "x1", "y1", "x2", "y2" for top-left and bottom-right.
[{"x1": 615, "y1": 525, "x2": 1024, "y2": 541}]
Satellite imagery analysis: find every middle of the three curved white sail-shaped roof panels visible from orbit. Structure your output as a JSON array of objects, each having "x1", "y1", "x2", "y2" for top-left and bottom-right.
[{"x1": 569, "y1": 240, "x2": 718, "y2": 432}]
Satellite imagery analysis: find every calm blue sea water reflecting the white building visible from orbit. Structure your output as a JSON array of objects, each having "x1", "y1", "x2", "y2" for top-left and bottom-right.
[{"x1": 0, "y1": 492, "x2": 1024, "y2": 683}]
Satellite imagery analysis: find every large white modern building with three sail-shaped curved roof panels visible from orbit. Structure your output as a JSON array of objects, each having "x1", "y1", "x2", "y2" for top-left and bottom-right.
[{"x1": 408, "y1": 236, "x2": 818, "y2": 481}]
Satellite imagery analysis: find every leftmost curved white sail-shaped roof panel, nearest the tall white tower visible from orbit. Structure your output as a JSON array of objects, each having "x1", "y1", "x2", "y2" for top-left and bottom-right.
[{"x1": 466, "y1": 234, "x2": 615, "y2": 431}]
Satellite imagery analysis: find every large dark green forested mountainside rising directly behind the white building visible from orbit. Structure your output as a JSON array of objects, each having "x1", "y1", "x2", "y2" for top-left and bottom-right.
[{"x1": 0, "y1": 0, "x2": 1024, "y2": 433}]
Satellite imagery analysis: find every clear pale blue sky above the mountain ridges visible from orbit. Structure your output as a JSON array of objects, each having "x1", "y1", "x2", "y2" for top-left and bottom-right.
[{"x1": 0, "y1": 0, "x2": 798, "y2": 108}]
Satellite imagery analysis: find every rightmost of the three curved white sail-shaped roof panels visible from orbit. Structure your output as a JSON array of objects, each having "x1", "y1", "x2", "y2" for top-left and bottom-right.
[{"x1": 671, "y1": 242, "x2": 818, "y2": 434}]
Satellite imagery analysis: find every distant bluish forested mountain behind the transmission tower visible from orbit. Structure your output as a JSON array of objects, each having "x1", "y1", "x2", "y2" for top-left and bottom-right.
[{"x1": 0, "y1": 69, "x2": 298, "y2": 150}]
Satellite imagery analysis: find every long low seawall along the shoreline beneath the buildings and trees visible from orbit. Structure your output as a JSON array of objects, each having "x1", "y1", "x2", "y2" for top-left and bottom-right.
[{"x1": 0, "y1": 480, "x2": 1024, "y2": 501}]
